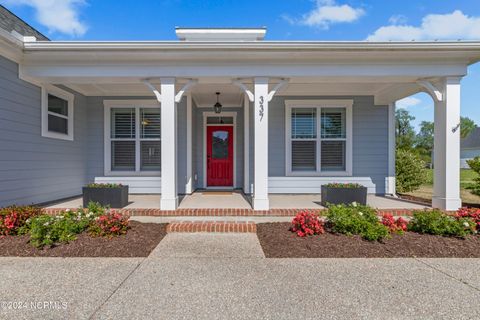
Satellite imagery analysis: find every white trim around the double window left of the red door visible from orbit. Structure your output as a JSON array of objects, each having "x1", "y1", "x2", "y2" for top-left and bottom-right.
[{"x1": 103, "y1": 99, "x2": 162, "y2": 177}]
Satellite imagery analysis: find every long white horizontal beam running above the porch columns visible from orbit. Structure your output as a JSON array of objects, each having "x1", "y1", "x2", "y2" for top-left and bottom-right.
[{"x1": 19, "y1": 61, "x2": 467, "y2": 83}]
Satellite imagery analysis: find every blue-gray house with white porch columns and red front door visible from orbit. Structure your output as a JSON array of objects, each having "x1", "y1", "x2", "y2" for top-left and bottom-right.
[{"x1": 0, "y1": 8, "x2": 480, "y2": 210}]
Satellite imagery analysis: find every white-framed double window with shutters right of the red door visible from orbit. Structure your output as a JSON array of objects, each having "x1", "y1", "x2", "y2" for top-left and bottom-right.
[{"x1": 286, "y1": 100, "x2": 353, "y2": 176}]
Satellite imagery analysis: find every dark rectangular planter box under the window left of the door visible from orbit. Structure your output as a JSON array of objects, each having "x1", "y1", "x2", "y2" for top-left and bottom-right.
[{"x1": 83, "y1": 183, "x2": 128, "y2": 208}]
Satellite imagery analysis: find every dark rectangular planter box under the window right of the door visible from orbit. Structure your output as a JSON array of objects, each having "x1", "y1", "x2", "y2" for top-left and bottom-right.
[{"x1": 322, "y1": 183, "x2": 367, "y2": 206}]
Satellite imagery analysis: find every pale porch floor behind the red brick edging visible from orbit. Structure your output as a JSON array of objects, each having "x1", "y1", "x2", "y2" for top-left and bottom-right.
[{"x1": 45, "y1": 192, "x2": 425, "y2": 209}]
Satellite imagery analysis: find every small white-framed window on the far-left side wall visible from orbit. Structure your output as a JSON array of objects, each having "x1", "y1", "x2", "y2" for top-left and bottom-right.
[{"x1": 42, "y1": 86, "x2": 74, "y2": 140}]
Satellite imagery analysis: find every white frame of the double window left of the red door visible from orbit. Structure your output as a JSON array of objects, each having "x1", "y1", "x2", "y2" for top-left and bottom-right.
[{"x1": 103, "y1": 100, "x2": 162, "y2": 176}]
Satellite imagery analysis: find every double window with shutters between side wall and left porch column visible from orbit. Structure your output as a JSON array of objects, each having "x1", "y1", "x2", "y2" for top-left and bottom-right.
[{"x1": 105, "y1": 101, "x2": 161, "y2": 175}]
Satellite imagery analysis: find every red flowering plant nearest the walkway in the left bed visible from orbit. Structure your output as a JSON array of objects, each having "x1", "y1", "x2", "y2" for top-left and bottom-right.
[{"x1": 89, "y1": 210, "x2": 130, "y2": 238}]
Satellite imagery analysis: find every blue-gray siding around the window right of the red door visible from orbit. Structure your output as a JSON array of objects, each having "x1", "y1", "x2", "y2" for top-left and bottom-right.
[{"x1": 266, "y1": 96, "x2": 388, "y2": 194}]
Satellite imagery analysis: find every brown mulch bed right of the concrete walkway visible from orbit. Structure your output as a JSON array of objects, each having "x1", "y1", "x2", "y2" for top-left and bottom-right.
[{"x1": 257, "y1": 223, "x2": 480, "y2": 258}]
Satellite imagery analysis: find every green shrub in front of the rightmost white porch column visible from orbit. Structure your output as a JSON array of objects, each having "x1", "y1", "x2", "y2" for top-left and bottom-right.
[{"x1": 408, "y1": 210, "x2": 475, "y2": 238}]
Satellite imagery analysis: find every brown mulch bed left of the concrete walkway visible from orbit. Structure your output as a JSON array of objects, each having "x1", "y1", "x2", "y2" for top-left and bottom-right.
[{"x1": 0, "y1": 221, "x2": 167, "y2": 257}]
